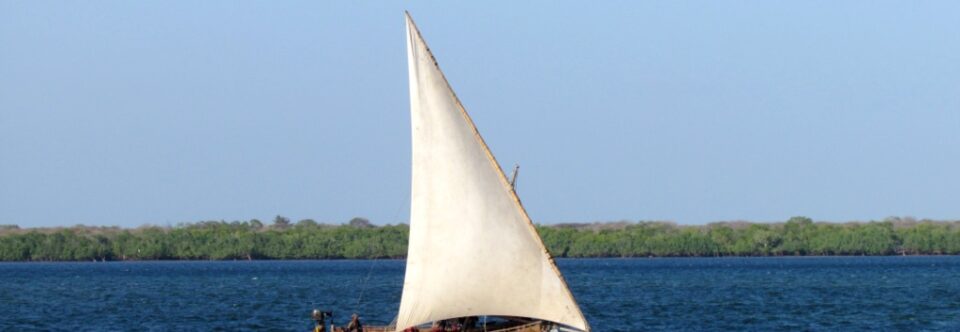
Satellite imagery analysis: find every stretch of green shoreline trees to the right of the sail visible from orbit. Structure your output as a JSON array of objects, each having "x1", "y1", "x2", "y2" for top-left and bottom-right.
[{"x1": 540, "y1": 217, "x2": 960, "y2": 257}]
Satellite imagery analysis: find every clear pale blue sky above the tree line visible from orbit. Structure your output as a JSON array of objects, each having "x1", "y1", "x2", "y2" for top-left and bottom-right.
[{"x1": 0, "y1": 1, "x2": 960, "y2": 226}]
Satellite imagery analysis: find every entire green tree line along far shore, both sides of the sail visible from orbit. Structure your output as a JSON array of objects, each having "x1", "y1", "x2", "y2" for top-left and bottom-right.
[{"x1": 0, "y1": 216, "x2": 960, "y2": 261}]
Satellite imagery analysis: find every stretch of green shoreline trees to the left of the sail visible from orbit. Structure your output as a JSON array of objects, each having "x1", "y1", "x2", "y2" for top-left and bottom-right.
[{"x1": 0, "y1": 216, "x2": 408, "y2": 261}]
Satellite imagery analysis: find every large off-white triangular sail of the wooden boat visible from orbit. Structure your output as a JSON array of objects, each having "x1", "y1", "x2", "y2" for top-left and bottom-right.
[{"x1": 396, "y1": 15, "x2": 589, "y2": 331}]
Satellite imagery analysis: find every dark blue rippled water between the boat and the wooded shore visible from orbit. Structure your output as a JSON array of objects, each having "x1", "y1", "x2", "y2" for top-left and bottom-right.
[{"x1": 0, "y1": 256, "x2": 960, "y2": 331}]
